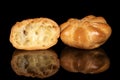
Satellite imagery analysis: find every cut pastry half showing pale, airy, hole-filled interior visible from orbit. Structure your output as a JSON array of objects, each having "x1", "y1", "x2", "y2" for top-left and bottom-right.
[{"x1": 10, "y1": 18, "x2": 60, "y2": 50}]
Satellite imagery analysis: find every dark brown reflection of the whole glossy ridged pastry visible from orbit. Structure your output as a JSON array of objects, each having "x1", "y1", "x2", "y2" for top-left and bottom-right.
[{"x1": 60, "y1": 47, "x2": 110, "y2": 74}]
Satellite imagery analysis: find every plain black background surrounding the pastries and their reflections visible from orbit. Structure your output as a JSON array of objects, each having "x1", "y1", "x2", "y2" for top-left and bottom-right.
[{"x1": 0, "y1": 0, "x2": 116, "y2": 80}]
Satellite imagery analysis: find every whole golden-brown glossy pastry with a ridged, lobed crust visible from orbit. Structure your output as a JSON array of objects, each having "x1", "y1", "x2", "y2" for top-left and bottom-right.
[{"x1": 60, "y1": 15, "x2": 112, "y2": 49}]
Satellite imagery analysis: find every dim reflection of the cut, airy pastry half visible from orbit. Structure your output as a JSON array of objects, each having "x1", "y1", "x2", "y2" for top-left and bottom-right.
[{"x1": 11, "y1": 50, "x2": 60, "y2": 78}]
